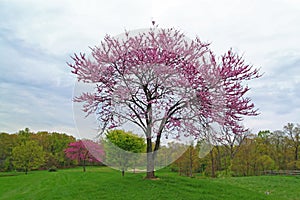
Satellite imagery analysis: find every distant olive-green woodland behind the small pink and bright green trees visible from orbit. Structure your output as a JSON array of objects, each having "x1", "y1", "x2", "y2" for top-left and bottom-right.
[{"x1": 0, "y1": 123, "x2": 300, "y2": 177}]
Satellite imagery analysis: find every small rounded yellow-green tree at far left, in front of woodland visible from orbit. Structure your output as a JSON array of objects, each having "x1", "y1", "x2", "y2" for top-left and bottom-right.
[{"x1": 12, "y1": 141, "x2": 44, "y2": 174}]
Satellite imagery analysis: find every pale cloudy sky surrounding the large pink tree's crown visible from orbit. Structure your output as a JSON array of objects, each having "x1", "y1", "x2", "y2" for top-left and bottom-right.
[{"x1": 0, "y1": 0, "x2": 300, "y2": 137}]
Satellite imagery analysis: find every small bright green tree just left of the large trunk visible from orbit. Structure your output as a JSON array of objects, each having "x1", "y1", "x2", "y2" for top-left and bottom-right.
[{"x1": 105, "y1": 130, "x2": 146, "y2": 176}]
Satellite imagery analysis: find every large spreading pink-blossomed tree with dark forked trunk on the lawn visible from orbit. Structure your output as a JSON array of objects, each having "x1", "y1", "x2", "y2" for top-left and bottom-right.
[{"x1": 69, "y1": 27, "x2": 260, "y2": 179}]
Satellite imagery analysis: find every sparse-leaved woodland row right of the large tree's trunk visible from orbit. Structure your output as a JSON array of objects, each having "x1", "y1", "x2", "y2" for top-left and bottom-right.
[{"x1": 170, "y1": 123, "x2": 300, "y2": 177}]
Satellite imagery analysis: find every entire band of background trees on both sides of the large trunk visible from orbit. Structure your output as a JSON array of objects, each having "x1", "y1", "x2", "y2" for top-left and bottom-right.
[{"x1": 0, "y1": 123, "x2": 300, "y2": 177}]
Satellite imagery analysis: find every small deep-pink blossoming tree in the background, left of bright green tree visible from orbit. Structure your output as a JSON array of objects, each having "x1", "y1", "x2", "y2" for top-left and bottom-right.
[{"x1": 65, "y1": 140, "x2": 104, "y2": 172}]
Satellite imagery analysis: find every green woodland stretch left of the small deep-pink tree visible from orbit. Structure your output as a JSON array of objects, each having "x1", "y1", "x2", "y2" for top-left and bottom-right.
[{"x1": 0, "y1": 128, "x2": 76, "y2": 172}]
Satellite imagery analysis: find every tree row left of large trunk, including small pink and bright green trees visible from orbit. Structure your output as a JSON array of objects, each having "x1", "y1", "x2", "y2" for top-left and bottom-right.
[{"x1": 0, "y1": 128, "x2": 146, "y2": 173}]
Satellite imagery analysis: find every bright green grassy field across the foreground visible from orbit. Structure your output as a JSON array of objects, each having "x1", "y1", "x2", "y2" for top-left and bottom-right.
[{"x1": 0, "y1": 167, "x2": 300, "y2": 200}]
